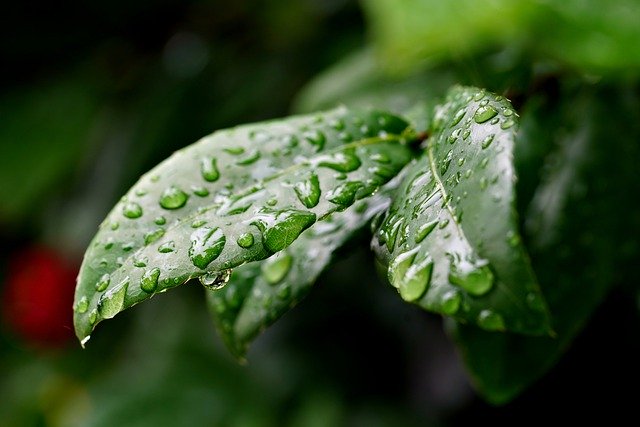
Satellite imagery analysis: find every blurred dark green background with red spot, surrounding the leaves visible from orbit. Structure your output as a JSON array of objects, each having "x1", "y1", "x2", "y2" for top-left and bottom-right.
[{"x1": 0, "y1": 0, "x2": 640, "y2": 426}]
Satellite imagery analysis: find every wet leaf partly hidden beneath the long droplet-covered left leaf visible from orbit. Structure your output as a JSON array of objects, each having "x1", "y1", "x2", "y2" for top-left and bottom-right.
[{"x1": 207, "y1": 192, "x2": 396, "y2": 358}]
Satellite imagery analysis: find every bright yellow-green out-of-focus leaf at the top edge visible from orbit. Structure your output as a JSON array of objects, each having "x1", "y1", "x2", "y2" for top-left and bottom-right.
[{"x1": 363, "y1": 0, "x2": 532, "y2": 74}]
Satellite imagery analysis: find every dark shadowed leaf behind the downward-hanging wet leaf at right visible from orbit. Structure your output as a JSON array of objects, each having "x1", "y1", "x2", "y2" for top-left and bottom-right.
[{"x1": 452, "y1": 83, "x2": 640, "y2": 404}]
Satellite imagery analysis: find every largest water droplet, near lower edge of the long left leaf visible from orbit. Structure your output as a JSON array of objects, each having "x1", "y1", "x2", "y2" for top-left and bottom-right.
[{"x1": 252, "y1": 209, "x2": 316, "y2": 253}]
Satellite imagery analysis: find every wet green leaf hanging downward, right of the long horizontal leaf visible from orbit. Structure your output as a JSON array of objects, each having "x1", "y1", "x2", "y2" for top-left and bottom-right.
[{"x1": 372, "y1": 87, "x2": 550, "y2": 334}]
